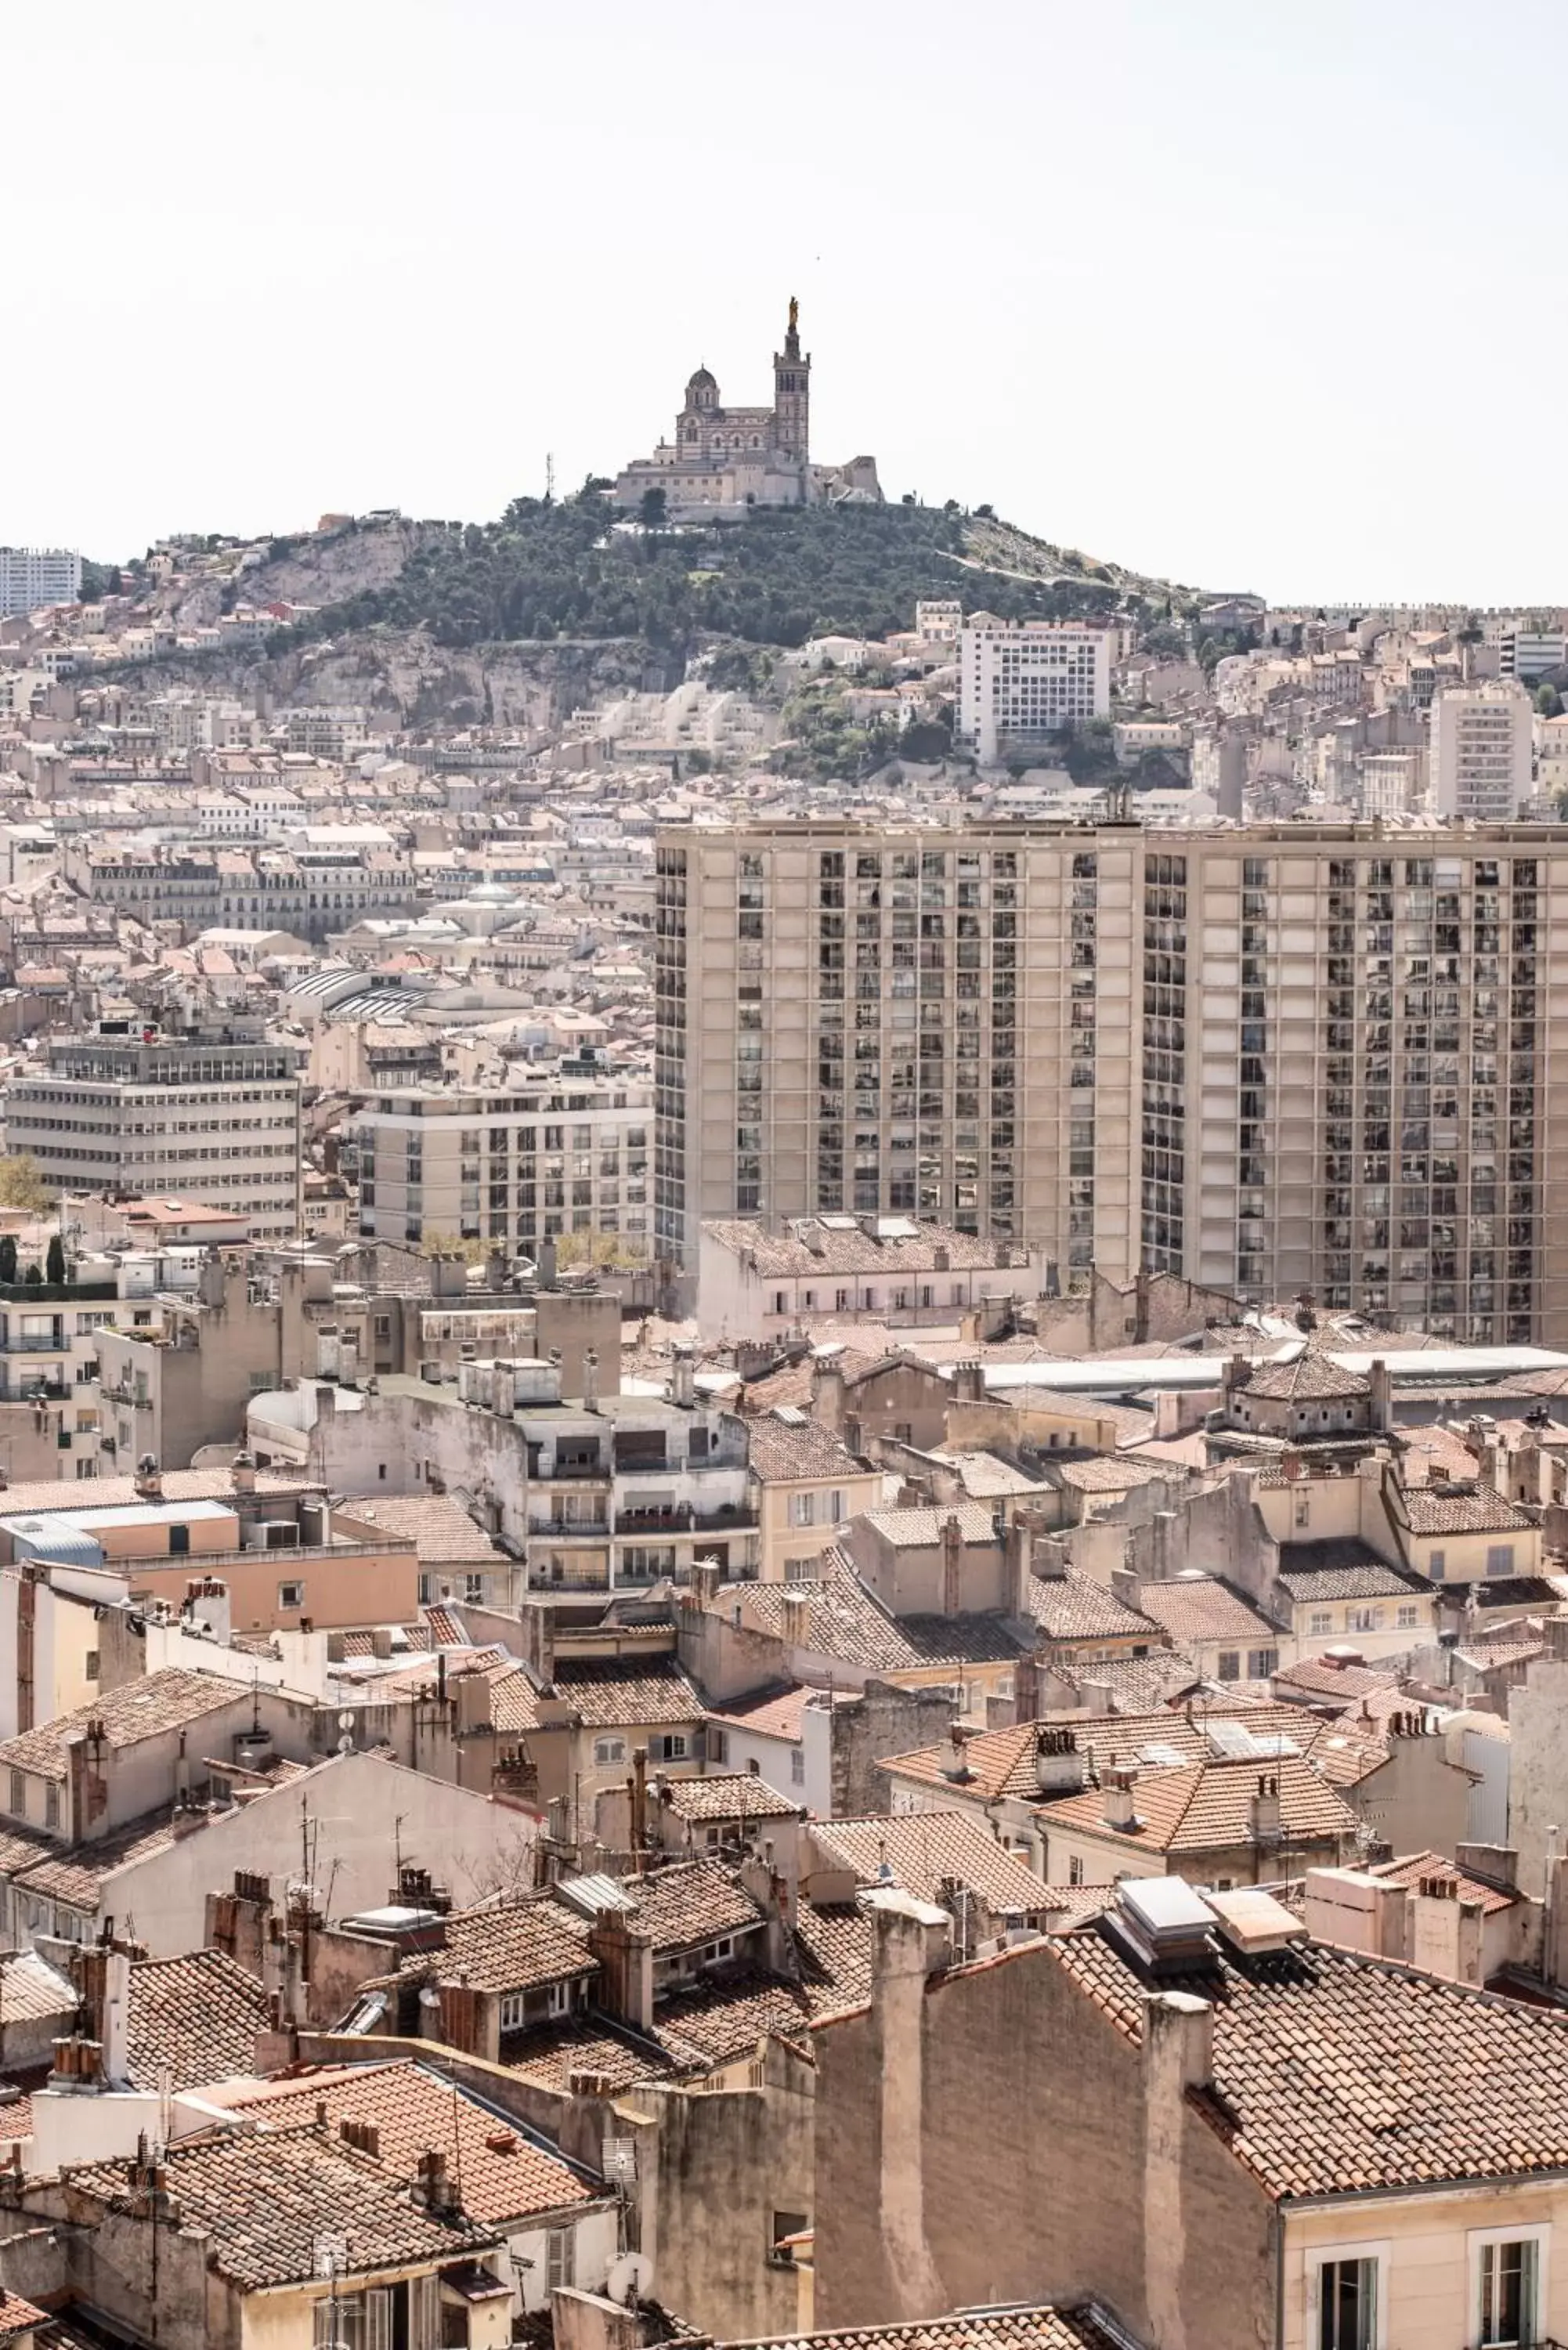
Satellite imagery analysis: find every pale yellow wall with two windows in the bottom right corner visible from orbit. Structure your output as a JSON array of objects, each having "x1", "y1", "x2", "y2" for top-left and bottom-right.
[{"x1": 1281, "y1": 2181, "x2": 1568, "y2": 2350}]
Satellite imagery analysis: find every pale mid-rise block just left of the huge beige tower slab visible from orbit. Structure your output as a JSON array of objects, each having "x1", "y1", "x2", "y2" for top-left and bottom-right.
[{"x1": 345, "y1": 1062, "x2": 653, "y2": 1257}]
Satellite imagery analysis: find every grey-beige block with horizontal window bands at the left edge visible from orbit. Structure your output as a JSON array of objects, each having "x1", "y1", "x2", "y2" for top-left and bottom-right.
[{"x1": 5, "y1": 1022, "x2": 301, "y2": 1241}]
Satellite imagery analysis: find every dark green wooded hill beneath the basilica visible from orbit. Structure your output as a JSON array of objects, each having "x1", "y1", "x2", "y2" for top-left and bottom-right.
[{"x1": 291, "y1": 484, "x2": 1197, "y2": 653}]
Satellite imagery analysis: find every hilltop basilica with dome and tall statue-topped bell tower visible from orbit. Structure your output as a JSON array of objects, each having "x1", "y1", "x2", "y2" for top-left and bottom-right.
[{"x1": 616, "y1": 301, "x2": 882, "y2": 522}]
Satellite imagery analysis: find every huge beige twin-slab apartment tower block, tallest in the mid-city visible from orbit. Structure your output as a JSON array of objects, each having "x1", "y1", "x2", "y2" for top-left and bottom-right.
[{"x1": 656, "y1": 822, "x2": 1568, "y2": 1344}]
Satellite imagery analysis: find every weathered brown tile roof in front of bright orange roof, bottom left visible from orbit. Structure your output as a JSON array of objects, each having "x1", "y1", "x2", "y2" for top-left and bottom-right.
[{"x1": 63, "y1": 2129, "x2": 496, "y2": 2291}]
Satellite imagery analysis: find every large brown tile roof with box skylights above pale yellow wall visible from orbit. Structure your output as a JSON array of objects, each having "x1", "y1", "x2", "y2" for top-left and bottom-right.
[{"x1": 1049, "y1": 1927, "x2": 1568, "y2": 2195}]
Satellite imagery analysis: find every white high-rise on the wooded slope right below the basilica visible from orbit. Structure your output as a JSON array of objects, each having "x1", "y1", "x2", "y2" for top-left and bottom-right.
[{"x1": 959, "y1": 611, "x2": 1115, "y2": 766}]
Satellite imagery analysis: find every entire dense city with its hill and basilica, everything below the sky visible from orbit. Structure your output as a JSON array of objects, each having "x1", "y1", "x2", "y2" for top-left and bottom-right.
[{"x1": 0, "y1": 266, "x2": 1568, "y2": 2350}]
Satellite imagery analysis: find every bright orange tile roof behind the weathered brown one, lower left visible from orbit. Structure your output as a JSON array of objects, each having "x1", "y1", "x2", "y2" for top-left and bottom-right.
[{"x1": 228, "y1": 2063, "x2": 602, "y2": 2228}]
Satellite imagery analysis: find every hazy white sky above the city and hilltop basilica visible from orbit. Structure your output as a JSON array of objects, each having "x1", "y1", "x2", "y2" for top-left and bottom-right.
[{"x1": 0, "y1": 0, "x2": 1568, "y2": 602}]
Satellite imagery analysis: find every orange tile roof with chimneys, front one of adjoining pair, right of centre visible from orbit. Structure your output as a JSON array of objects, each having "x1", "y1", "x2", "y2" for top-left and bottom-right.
[{"x1": 1044, "y1": 1755, "x2": 1357, "y2": 1854}]
